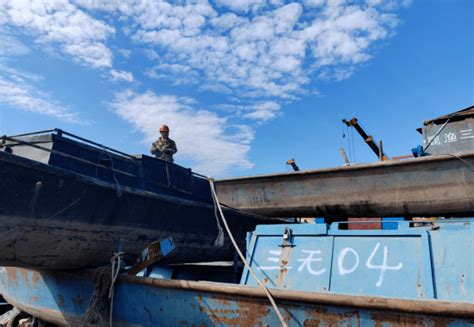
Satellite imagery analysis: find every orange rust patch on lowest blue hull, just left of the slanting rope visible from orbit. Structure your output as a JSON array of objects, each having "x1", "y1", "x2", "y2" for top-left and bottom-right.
[{"x1": 198, "y1": 295, "x2": 270, "y2": 326}]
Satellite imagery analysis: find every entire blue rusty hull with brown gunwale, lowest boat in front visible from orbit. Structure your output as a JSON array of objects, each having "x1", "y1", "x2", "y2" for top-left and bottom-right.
[{"x1": 0, "y1": 268, "x2": 474, "y2": 326}]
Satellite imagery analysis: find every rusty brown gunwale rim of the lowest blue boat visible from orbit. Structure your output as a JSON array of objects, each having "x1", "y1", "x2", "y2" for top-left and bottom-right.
[{"x1": 3, "y1": 267, "x2": 474, "y2": 318}]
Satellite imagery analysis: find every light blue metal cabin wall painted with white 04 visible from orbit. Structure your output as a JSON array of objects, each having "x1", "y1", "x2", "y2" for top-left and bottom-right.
[{"x1": 241, "y1": 220, "x2": 474, "y2": 303}]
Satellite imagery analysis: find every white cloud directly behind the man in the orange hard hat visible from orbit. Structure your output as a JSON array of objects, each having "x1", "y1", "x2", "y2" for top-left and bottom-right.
[{"x1": 111, "y1": 91, "x2": 253, "y2": 176}]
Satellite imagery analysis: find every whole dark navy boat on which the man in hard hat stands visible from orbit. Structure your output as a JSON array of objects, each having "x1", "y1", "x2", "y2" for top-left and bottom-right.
[{"x1": 0, "y1": 129, "x2": 269, "y2": 269}]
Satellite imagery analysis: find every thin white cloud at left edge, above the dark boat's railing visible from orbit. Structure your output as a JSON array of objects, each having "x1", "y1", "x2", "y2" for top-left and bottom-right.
[{"x1": 0, "y1": 65, "x2": 89, "y2": 124}]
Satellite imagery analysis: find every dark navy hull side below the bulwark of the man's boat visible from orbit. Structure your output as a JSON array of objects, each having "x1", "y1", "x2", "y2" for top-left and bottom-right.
[{"x1": 0, "y1": 152, "x2": 268, "y2": 269}]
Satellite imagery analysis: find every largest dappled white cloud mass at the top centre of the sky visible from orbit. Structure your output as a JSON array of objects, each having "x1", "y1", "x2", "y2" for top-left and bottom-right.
[{"x1": 79, "y1": 0, "x2": 397, "y2": 105}]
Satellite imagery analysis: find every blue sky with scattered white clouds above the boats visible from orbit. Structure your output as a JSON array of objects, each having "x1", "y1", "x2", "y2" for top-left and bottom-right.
[{"x1": 0, "y1": 0, "x2": 474, "y2": 177}]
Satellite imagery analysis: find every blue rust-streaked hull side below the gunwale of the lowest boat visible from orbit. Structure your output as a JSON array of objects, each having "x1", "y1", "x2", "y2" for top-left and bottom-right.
[{"x1": 0, "y1": 268, "x2": 474, "y2": 327}]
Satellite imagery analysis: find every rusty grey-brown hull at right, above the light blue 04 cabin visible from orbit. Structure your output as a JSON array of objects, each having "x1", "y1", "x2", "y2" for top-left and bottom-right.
[{"x1": 216, "y1": 152, "x2": 474, "y2": 218}]
